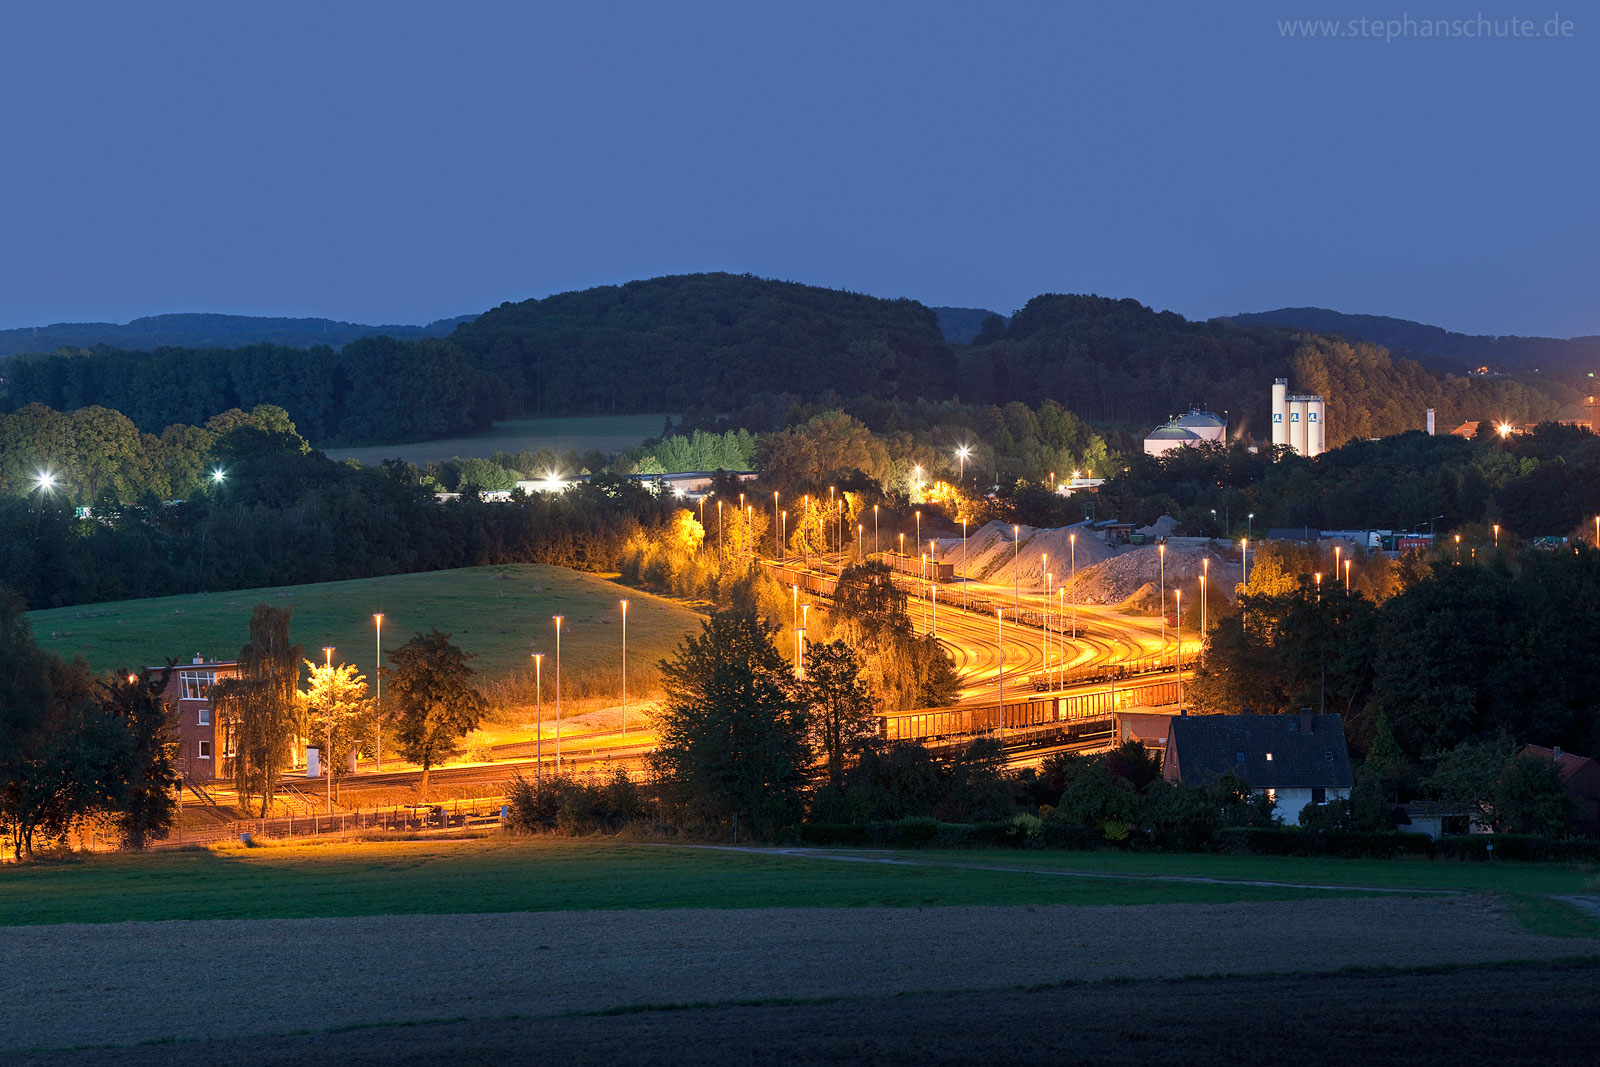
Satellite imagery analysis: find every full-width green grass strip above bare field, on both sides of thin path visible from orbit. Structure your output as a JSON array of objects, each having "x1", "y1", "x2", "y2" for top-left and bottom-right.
[{"x1": 0, "y1": 838, "x2": 1600, "y2": 937}]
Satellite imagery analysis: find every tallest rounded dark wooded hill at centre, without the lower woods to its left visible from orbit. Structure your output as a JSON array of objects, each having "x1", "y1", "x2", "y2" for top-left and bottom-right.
[{"x1": 451, "y1": 274, "x2": 955, "y2": 418}]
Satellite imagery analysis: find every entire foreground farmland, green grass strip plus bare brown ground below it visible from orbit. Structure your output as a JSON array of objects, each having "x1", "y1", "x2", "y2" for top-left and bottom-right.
[{"x1": 0, "y1": 835, "x2": 1600, "y2": 1067}]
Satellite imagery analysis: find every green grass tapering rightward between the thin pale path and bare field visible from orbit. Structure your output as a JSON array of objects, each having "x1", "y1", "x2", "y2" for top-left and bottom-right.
[{"x1": 0, "y1": 838, "x2": 1376, "y2": 926}]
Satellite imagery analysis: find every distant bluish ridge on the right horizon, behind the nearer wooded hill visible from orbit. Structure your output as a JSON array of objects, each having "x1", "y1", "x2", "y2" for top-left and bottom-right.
[{"x1": 1224, "y1": 307, "x2": 1600, "y2": 373}]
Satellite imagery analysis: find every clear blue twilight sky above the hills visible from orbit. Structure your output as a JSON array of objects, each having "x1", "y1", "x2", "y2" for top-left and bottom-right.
[{"x1": 0, "y1": 0, "x2": 1600, "y2": 336}]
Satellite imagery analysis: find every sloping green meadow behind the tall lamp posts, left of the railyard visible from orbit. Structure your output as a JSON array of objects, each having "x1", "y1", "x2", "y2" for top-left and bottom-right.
[{"x1": 29, "y1": 563, "x2": 699, "y2": 681}]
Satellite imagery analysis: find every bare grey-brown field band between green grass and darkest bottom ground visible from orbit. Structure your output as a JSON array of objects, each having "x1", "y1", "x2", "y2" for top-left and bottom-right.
[{"x1": 0, "y1": 897, "x2": 1595, "y2": 1049}]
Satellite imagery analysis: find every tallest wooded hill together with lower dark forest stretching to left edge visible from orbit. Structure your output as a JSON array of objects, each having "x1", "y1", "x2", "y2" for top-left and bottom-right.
[{"x1": 0, "y1": 274, "x2": 955, "y2": 446}]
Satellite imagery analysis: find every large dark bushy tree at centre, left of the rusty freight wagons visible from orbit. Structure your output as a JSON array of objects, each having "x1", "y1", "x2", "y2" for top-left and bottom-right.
[{"x1": 651, "y1": 611, "x2": 811, "y2": 830}]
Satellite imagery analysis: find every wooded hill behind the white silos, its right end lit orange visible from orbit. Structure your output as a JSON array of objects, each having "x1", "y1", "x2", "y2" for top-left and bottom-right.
[{"x1": 960, "y1": 294, "x2": 1578, "y2": 448}]
